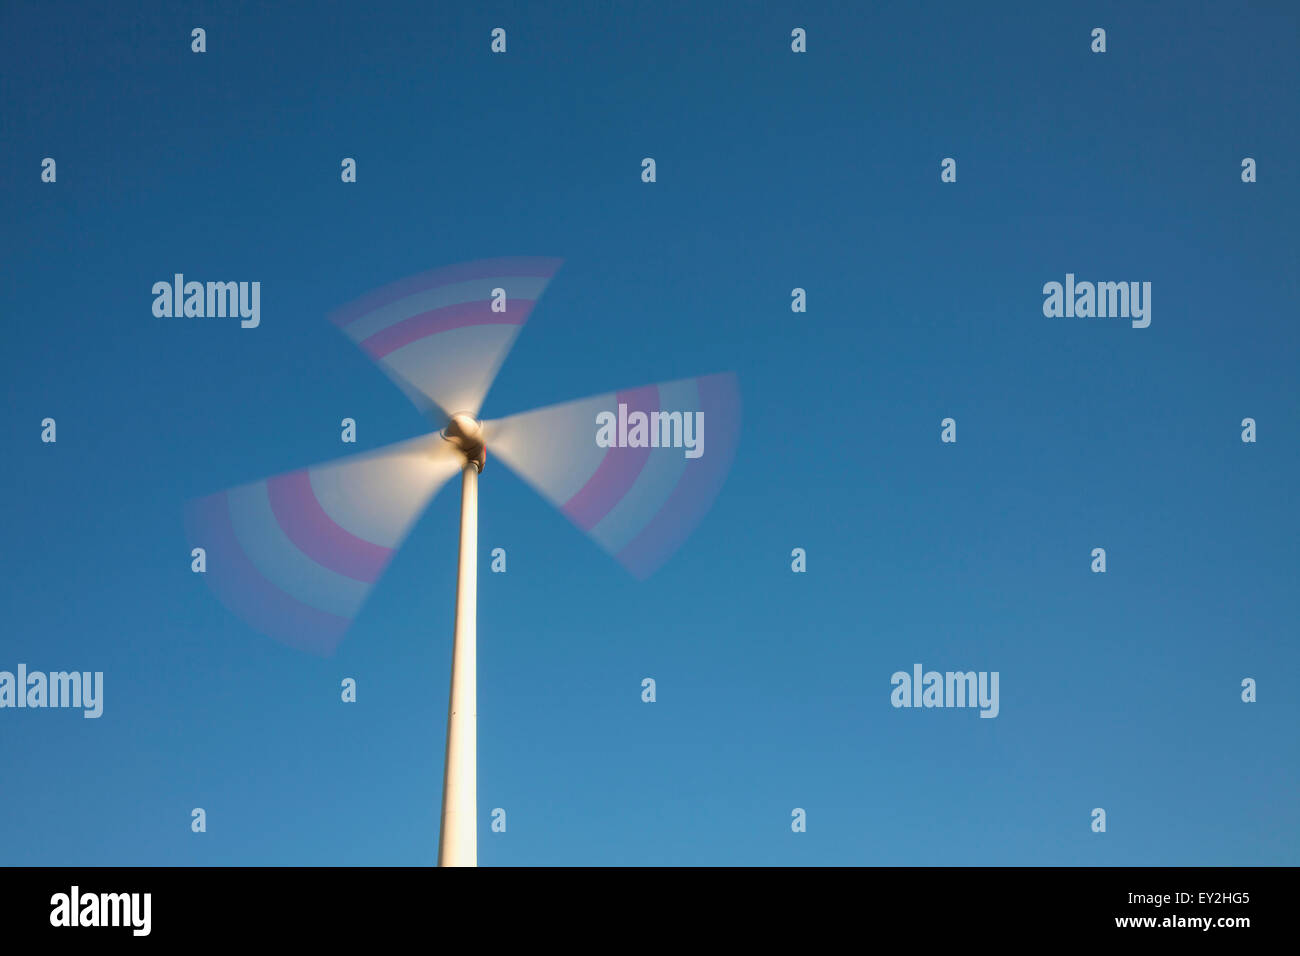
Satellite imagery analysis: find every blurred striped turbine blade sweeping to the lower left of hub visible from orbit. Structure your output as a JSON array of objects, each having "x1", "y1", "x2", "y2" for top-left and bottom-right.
[{"x1": 186, "y1": 433, "x2": 462, "y2": 657}]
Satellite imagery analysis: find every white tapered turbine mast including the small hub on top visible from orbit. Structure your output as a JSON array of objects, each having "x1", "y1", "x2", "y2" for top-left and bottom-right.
[{"x1": 438, "y1": 416, "x2": 485, "y2": 866}]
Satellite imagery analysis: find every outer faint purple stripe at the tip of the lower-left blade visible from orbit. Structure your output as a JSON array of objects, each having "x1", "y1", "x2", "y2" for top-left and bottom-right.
[{"x1": 185, "y1": 492, "x2": 352, "y2": 657}]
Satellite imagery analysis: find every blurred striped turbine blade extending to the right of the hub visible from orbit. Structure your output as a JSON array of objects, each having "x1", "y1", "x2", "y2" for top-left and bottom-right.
[{"x1": 484, "y1": 372, "x2": 740, "y2": 579}]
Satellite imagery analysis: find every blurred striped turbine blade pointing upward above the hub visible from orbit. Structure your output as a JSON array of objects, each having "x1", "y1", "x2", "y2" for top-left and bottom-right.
[{"x1": 330, "y1": 258, "x2": 562, "y2": 419}]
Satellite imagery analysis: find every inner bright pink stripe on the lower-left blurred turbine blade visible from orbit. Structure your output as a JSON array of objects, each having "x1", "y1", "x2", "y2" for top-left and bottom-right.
[{"x1": 267, "y1": 470, "x2": 393, "y2": 583}]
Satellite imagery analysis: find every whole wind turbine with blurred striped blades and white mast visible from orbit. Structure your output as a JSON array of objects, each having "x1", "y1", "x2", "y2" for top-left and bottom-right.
[{"x1": 186, "y1": 258, "x2": 740, "y2": 866}]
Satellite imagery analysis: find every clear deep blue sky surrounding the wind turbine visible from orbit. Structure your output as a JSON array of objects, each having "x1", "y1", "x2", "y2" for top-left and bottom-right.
[{"x1": 0, "y1": 1, "x2": 1300, "y2": 865}]
